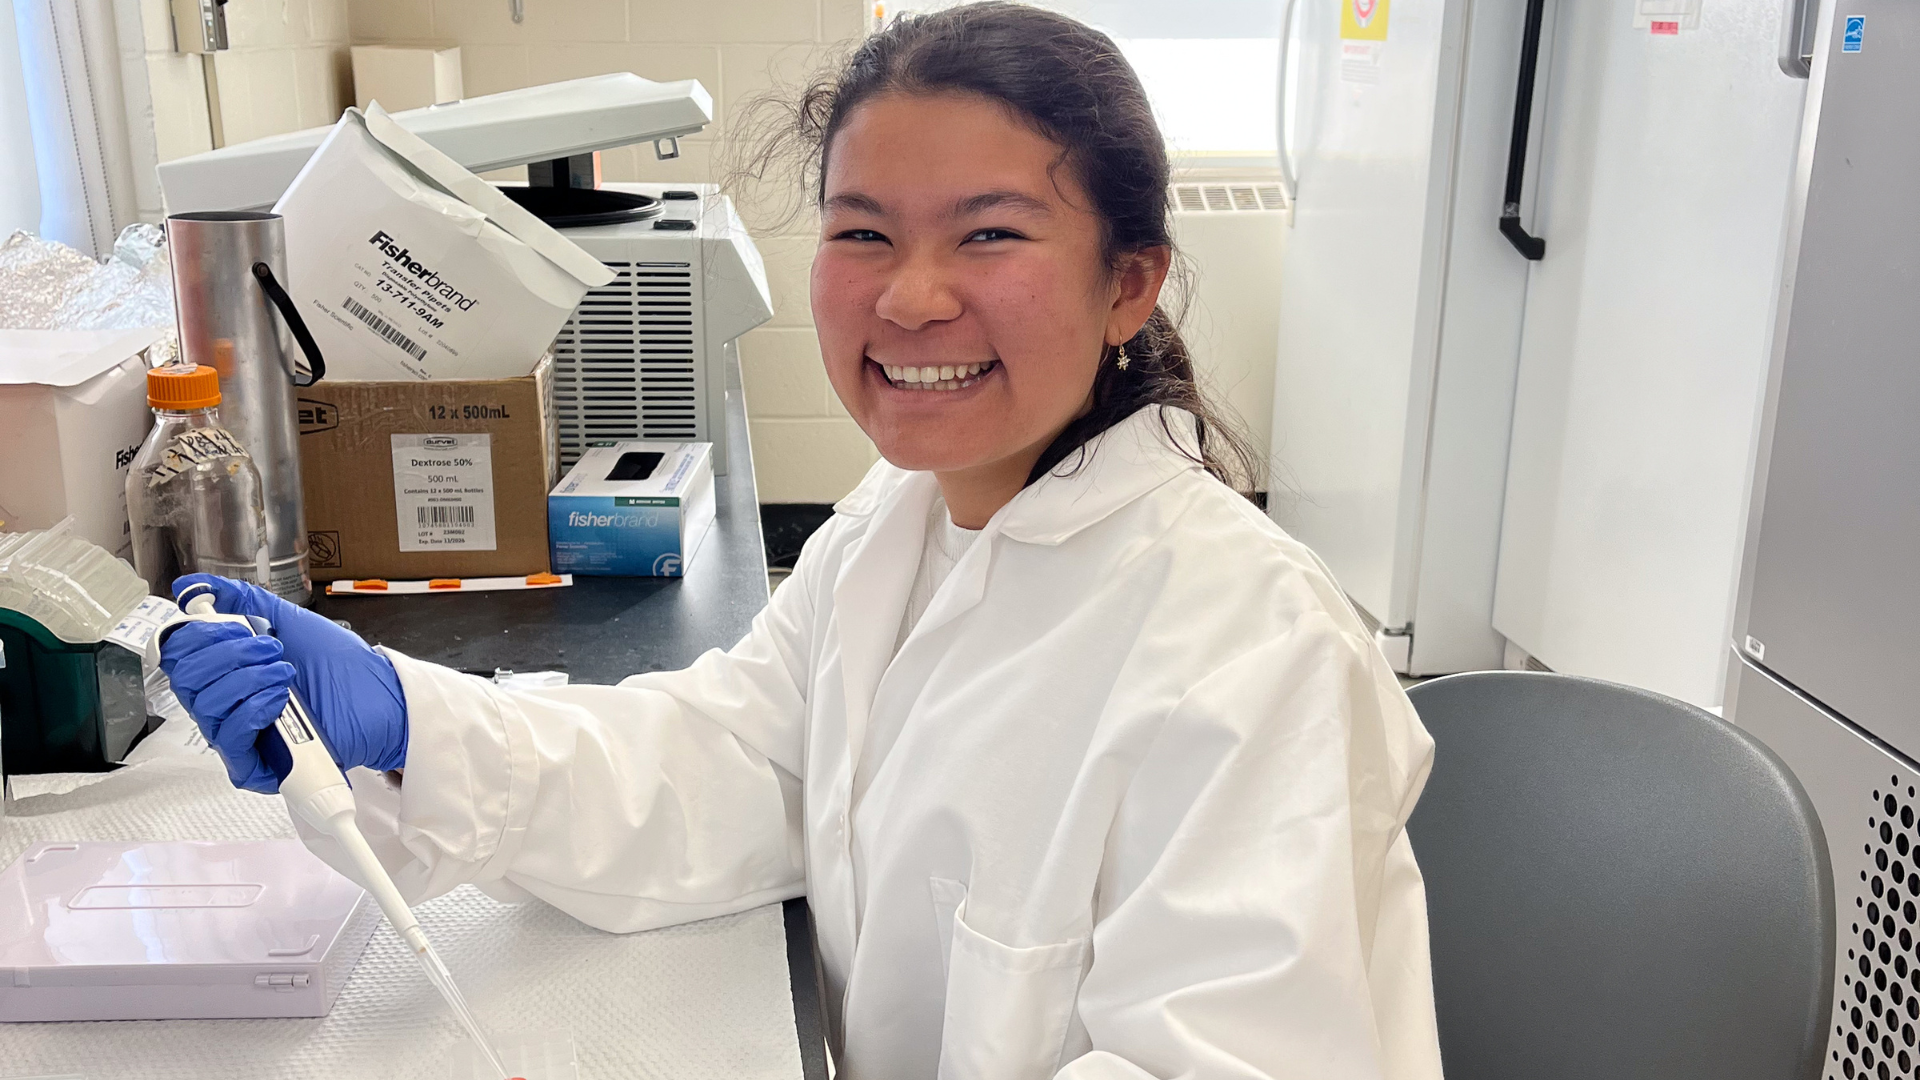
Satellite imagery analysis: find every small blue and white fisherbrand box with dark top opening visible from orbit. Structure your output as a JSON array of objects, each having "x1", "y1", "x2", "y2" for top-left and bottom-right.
[{"x1": 547, "y1": 442, "x2": 714, "y2": 577}]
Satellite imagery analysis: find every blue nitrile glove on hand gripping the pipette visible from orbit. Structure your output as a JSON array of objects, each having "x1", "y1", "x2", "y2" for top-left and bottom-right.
[{"x1": 159, "y1": 575, "x2": 407, "y2": 794}]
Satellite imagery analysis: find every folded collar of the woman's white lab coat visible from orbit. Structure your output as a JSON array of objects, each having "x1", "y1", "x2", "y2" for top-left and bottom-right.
[{"x1": 833, "y1": 405, "x2": 1200, "y2": 548}]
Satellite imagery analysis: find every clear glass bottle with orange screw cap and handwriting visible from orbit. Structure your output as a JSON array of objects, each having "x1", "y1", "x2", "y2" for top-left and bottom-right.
[{"x1": 127, "y1": 355, "x2": 269, "y2": 596}]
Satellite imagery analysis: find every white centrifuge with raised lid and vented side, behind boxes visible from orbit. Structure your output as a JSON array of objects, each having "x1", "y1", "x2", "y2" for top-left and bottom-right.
[{"x1": 159, "y1": 73, "x2": 774, "y2": 475}]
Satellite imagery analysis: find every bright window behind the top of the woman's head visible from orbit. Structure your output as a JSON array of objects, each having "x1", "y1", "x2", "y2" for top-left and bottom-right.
[{"x1": 1041, "y1": 0, "x2": 1281, "y2": 171}]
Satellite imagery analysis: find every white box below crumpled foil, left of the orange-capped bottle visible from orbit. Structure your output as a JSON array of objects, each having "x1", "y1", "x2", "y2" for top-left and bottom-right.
[{"x1": 0, "y1": 331, "x2": 159, "y2": 559}]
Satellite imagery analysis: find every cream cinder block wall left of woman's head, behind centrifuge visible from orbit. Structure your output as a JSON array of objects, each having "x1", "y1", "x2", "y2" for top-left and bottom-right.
[{"x1": 351, "y1": 0, "x2": 876, "y2": 503}]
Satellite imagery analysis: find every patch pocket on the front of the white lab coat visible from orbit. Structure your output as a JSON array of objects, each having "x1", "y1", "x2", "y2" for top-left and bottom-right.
[{"x1": 939, "y1": 901, "x2": 1091, "y2": 1080}]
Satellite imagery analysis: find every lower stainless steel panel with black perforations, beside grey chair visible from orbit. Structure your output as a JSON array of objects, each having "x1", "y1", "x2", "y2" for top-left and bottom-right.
[{"x1": 1728, "y1": 655, "x2": 1920, "y2": 1080}]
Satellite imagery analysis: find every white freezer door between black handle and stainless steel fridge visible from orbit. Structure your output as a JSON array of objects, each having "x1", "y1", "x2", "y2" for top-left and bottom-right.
[{"x1": 1494, "y1": 0, "x2": 1807, "y2": 705}]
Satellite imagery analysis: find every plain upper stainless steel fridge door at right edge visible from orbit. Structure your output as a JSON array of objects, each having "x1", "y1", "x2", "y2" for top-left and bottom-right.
[{"x1": 1734, "y1": 0, "x2": 1920, "y2": 755}]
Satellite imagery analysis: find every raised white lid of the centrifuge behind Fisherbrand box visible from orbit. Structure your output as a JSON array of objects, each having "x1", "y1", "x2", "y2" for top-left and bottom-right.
[{"x1": 159, "y1": 71, "x2": 714, "y2": 213}]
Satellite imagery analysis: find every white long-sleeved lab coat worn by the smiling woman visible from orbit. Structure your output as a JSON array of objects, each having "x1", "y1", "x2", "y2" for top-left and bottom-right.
[{"x1": 326, "y1": 409, "x2": 1440, "y2": 1080}]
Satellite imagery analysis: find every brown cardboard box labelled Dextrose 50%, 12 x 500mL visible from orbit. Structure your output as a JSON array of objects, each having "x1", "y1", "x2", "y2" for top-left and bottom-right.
[{"x1": 300, "y1": 359, "x2": 561, "y2": 580}]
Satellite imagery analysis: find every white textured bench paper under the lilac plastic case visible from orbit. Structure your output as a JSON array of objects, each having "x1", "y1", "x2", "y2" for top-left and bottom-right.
[{"x1": 0, "y1": 759, "x2": 801, "y2": 1080}]
